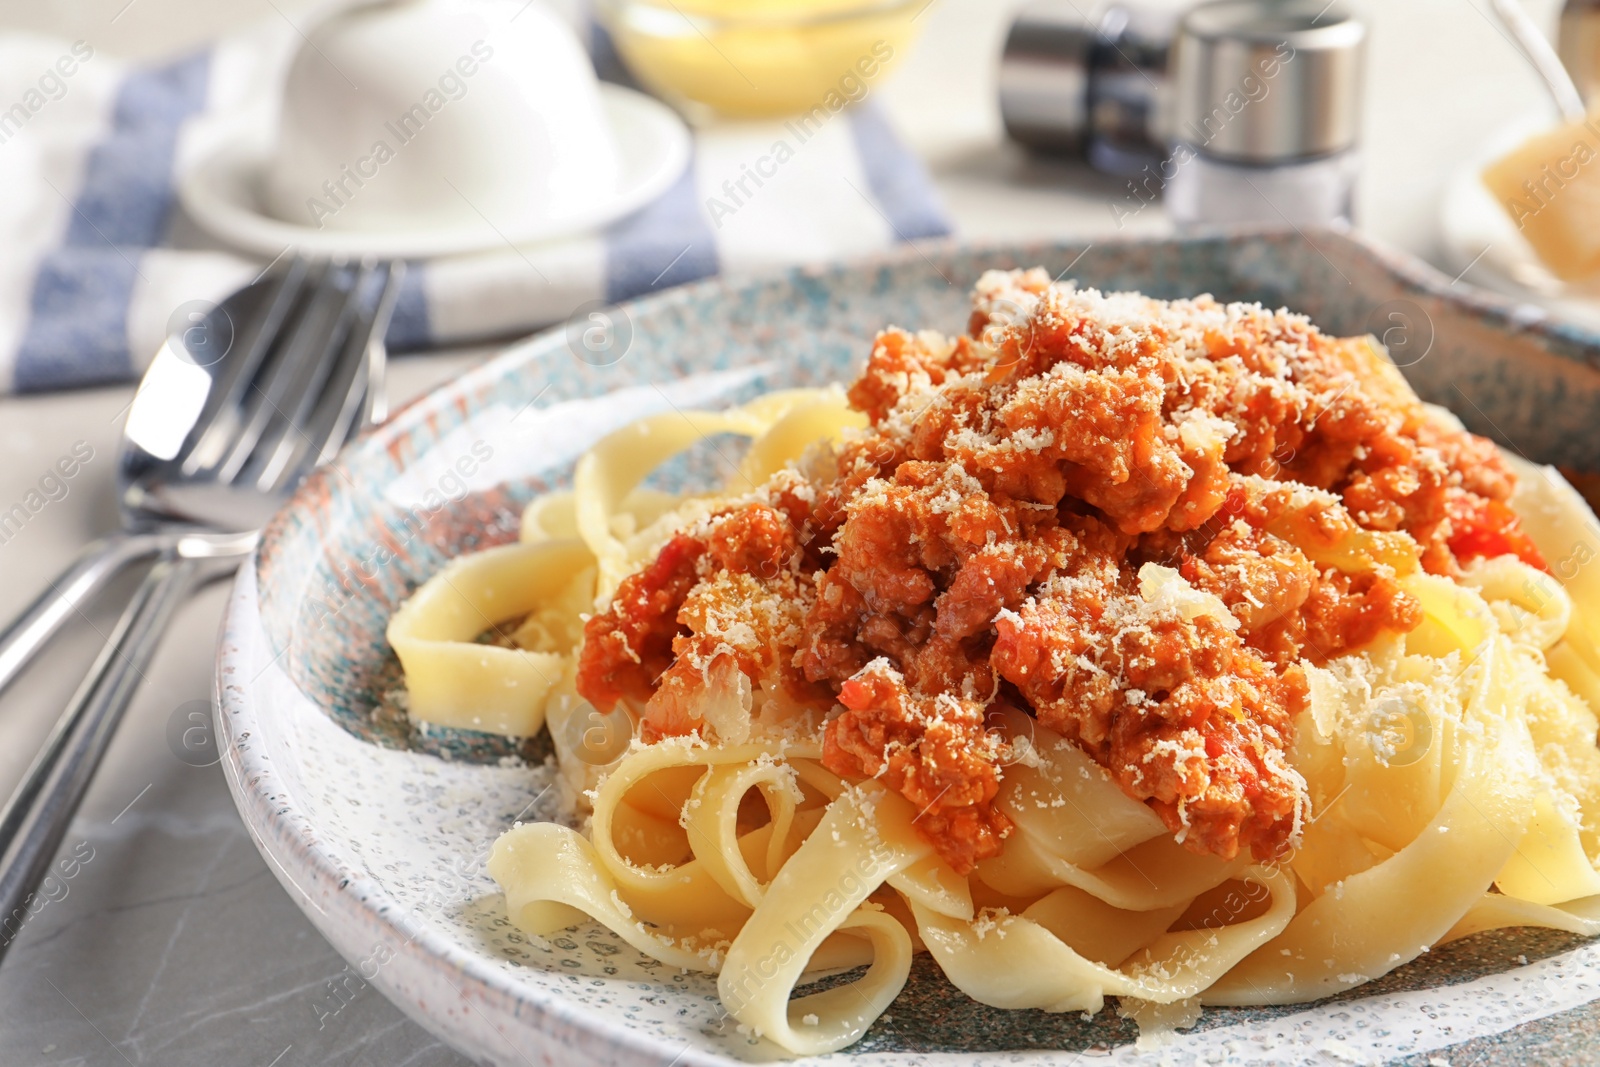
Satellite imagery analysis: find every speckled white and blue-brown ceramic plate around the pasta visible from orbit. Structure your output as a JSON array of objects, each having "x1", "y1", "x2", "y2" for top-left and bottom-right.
[{"x1": 218, "y1": 230, "x2": 1600, "y2": 1067}]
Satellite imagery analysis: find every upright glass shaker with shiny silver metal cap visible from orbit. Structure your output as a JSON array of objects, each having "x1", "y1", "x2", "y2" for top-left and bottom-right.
[{"x1": 1166, "y1": 0, "x2": 1366, "y2": 229}]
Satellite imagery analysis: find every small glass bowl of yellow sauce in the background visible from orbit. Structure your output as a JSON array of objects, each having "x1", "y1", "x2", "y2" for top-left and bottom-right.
[{"x1": 595, "y1": 0, "x2": 928, "y2": 118}]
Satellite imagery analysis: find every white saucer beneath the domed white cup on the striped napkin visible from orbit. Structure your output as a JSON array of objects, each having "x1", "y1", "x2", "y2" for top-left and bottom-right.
[{"x1": 178, "y1": 83, "x2": 690, "y2": 259}]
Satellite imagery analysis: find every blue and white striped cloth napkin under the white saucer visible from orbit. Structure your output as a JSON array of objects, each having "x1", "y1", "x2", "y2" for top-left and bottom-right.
[{"x1": 0, "y1": 22, "x2": 947, "y2": 392}]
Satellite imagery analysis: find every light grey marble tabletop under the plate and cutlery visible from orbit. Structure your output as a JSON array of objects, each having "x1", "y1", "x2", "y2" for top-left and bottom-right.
[{"x1": 0, "y1": 0, "x2": 1554, "y2": 1067}]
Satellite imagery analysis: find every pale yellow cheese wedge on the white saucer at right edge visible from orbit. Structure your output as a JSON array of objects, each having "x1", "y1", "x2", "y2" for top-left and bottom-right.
[{"x1": 1483, "y1": 114, "x2": 1600, "y2": 282}]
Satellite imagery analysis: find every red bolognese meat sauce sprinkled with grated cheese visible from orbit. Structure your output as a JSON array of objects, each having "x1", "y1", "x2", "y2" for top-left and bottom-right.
[{"x1": 578, "y1": 270, "x2": 1542, "y2": 873}]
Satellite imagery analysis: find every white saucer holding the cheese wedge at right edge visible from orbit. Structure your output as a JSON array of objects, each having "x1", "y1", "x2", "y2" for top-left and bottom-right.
[{"x1": 1438, "y1": 117, "x2": 1600, "y2": 326}]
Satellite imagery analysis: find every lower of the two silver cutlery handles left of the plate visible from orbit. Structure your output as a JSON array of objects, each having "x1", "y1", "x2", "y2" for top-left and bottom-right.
[{"x1": 0, "y1": 549, "x2": 200, "y2": 958}]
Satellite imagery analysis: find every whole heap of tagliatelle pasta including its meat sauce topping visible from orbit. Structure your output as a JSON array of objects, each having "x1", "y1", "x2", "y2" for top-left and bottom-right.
[{"x1": 389, "y1": 272, "x2": 1600, "y2": 1054}]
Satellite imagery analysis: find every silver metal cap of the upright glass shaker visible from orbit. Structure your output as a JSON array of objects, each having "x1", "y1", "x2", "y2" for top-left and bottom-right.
[{"x1": 1173, "y1": 0, "x2": 1366, "y2": 163}]
